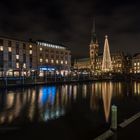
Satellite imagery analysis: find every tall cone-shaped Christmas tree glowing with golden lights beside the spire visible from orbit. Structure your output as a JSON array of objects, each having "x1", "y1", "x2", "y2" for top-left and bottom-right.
[{"x1": 102, "y1": 35, "x2": 112, "y2": 72}]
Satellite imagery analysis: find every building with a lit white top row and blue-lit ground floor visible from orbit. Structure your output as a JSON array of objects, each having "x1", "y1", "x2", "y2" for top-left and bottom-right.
[{"x1": 36, "y1": 41, "x2": 71, "y2": 74}]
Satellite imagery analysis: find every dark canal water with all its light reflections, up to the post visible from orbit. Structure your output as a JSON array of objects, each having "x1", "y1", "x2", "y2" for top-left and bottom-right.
[{"x1": 0, "y1": 82, "x2": 140, "y2": 140}]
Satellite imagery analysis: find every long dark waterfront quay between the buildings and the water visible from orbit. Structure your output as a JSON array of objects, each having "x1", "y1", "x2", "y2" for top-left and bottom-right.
[{"x1": 0, "y1": 72, "x2": 140, "y2": 88}]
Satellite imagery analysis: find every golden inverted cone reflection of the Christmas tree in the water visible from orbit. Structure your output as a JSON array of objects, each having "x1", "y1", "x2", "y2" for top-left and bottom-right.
[{"x1": 102, "y1": 83, "x2": 112, "y2": 122}]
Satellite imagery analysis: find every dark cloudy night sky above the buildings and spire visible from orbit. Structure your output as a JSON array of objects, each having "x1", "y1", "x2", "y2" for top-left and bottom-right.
[{"x1": 0, "y1": 0, "x2": 140, "y2": 58}]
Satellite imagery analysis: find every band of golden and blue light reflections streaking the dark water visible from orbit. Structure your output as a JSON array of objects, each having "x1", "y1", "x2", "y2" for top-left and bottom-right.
[{"x1": 0, "y1": 82, "x2": 140, "y2": 125}]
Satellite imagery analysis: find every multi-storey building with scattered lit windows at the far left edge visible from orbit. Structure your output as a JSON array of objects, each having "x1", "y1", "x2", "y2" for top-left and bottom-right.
[{"x1": 0, "y1": 37, "x2": 37, "y2": 76}]
